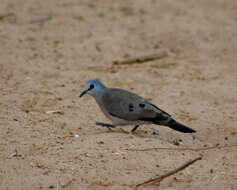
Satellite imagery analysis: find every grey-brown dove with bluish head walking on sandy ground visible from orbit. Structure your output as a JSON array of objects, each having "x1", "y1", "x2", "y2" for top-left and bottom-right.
[{"x1": 79, "y1": 80, "x2": 196, "y2": 133}]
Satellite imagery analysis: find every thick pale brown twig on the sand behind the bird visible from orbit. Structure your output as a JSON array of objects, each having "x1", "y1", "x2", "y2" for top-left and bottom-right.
[{"x1": 113, "y1": 51, "x2": 168, "y2": 65}]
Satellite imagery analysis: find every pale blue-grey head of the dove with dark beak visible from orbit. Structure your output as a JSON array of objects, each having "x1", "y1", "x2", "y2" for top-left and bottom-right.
[{"x1": 80, "y1": 80, "x2": 106, "y2": 97}]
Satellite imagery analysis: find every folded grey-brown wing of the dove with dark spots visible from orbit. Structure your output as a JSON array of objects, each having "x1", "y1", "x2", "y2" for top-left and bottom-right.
[{"x1": 102, "y1": 89, "x2": 169, "y2": 121}]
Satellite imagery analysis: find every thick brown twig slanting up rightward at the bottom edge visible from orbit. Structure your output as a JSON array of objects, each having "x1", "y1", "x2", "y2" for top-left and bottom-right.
[{"x1": 135, "y1": 157, "x2": 202, "y2": 189}]
